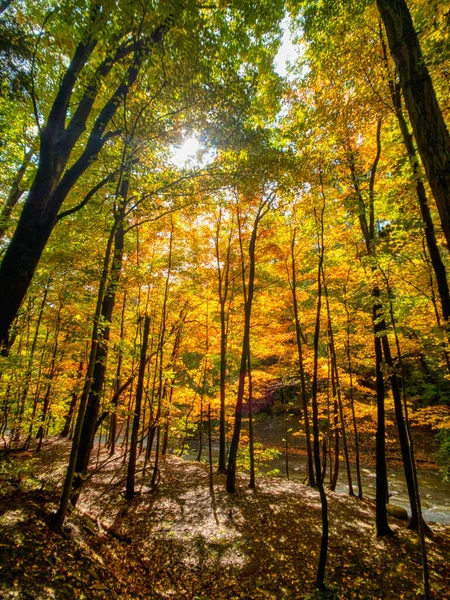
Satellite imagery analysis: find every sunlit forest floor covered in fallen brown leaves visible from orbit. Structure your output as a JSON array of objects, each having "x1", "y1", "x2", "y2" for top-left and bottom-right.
[{"x1": 0, "y1": 439, "x2": 450, "y2": 600}]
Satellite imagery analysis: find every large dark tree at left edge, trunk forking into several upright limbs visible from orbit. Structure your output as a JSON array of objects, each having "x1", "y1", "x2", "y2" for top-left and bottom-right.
[{"x1": 0, "y1": 1, "x2": 176, "y2": 344}]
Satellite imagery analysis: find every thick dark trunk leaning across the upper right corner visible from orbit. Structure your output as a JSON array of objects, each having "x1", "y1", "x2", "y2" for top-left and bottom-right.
[{"x1": 377, "y1": 0, "x2": 450, "y2": 248}]
